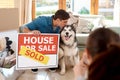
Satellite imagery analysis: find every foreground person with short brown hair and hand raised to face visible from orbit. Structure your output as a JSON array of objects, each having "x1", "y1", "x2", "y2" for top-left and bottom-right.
[{"x1": 73, "y1": 28, "x2": 120, "y2": 80}]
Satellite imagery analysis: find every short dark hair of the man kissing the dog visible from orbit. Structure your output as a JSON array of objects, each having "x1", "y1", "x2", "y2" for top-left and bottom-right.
[{"x1": 53, "y1": 9, "x2": 70, "y2": 20}]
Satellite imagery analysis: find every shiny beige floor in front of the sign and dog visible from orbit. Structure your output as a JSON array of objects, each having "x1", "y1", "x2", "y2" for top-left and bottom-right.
[{"x1": 17, "y1": 69, "x2": 74, "y2": 80}]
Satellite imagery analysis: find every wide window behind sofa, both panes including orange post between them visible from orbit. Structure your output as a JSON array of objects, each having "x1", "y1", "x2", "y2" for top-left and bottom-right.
[{"x1": 66, "y1": 0, "x2": 115, "y2": 20}]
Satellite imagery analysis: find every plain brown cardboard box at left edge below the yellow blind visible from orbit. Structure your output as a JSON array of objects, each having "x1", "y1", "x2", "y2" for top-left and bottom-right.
[{"x1": 0, "y1": 8, "x2": 19, "y2": 31}]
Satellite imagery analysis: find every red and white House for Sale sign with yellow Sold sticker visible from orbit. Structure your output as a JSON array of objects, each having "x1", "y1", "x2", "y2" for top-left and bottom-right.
[{"x1": 16, "y1": 33, "x2": 59, "y2": 69}]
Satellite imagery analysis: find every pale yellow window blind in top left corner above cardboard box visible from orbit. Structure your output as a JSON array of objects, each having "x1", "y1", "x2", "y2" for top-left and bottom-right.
[{"x1": 0, "y1": 0, "x2": 15, "y2": 8}]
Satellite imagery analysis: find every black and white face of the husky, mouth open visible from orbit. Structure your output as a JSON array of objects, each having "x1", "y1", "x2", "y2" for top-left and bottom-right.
[{"x1": 60, "y1": 25, "x2": 76, "y2": 45}]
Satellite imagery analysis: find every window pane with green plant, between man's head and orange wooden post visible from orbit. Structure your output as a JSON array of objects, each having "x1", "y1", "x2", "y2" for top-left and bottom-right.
[{"x1": 66, "y1": 0, "x2": 91, "y2": 14}]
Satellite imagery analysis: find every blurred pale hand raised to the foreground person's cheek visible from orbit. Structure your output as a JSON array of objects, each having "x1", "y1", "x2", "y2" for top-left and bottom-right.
[{"x1": 73, "y1": 51, "x2": 91, "y2": 80}]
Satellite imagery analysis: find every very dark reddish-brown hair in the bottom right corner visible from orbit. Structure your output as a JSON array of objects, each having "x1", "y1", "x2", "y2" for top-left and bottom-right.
[{"x1": 88, "y1": 44, "x2": 120, "y2": 80}]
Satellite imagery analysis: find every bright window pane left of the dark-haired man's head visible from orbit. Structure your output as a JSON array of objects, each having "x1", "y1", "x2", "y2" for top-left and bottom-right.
[{"x1": 36, "y1": 0, "x2": 58, "y2": 17}]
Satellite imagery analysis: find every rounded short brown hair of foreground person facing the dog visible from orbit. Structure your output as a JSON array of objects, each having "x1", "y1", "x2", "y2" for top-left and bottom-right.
[{"x1": 86, "y1": 28, "x2": 120, "y2": 57}]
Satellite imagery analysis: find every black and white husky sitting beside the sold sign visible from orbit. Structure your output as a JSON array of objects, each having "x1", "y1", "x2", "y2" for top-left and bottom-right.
[{"x1": 59, "y1": 24, "x2": 79, "y2": 74}]
